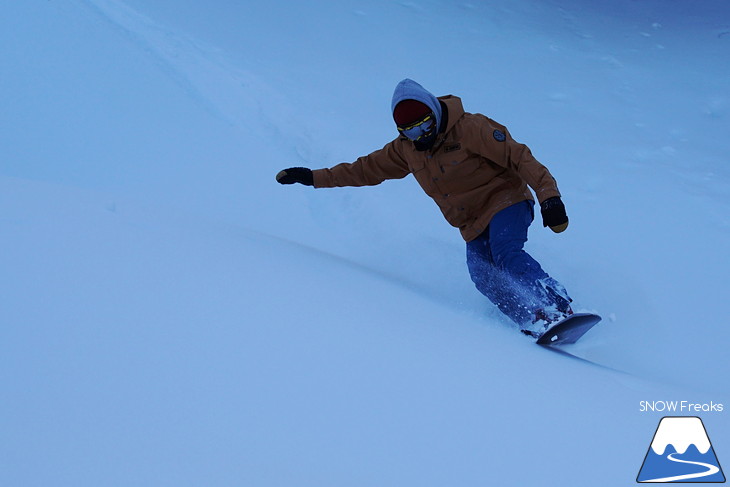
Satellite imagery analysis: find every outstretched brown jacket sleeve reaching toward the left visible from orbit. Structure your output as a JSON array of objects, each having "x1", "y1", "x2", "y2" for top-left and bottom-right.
[{"x1": 312, "y1": 139, "x2": 411, "y2": 188}]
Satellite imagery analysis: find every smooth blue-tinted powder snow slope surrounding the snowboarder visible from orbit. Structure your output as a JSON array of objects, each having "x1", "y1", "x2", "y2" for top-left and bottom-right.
[{"x1": 0, "y1": 0, "x2": 730, "y2": 487}]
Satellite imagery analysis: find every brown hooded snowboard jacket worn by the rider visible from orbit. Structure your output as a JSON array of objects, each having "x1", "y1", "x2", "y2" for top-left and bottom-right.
[{"x1": 313, "y1": 95, "x2": 560, "y2": 242}]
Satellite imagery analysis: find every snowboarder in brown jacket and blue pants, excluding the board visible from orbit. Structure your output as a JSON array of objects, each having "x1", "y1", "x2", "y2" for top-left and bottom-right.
[{"x1": 276, "y1": 79, "x2": 573, "y2": 336}]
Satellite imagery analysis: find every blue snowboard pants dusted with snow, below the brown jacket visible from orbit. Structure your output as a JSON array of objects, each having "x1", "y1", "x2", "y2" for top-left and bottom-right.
[{"x1": 466, "y1": 200, "x2": 570, "y2": 327}]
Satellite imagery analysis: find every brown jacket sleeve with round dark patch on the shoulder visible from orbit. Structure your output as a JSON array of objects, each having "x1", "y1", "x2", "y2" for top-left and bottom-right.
[{"x1": 470, "y1": 117, "x2": 560, "y2": 203}]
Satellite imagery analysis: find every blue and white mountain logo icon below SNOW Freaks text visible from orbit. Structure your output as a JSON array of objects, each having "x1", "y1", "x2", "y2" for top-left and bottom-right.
[{"x1": 636, "y1": 416, "x2": 725, "y2": 483}]
